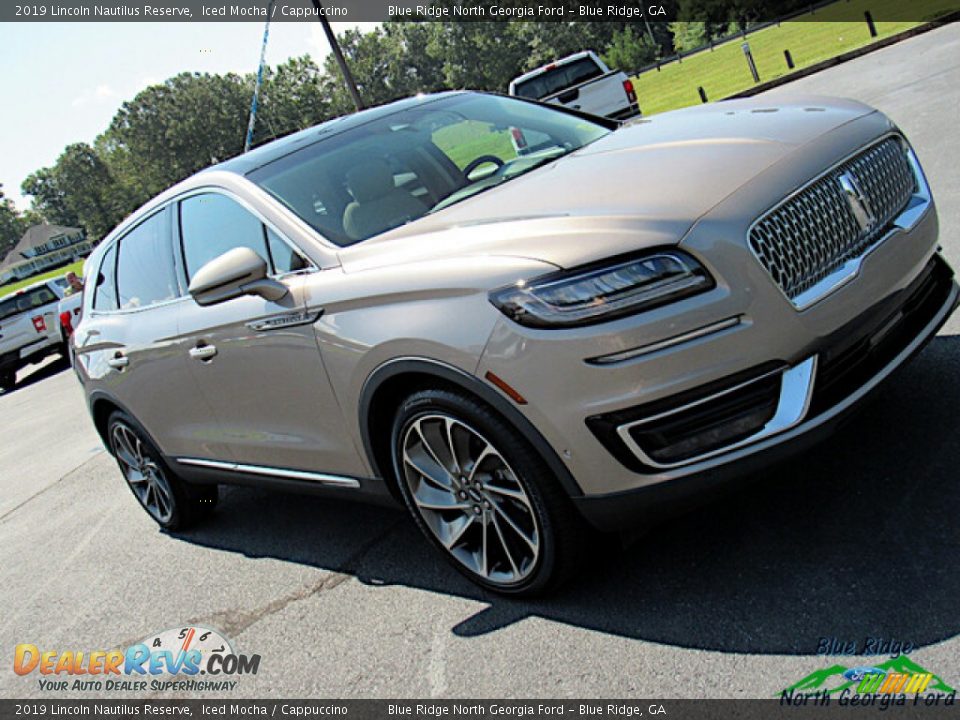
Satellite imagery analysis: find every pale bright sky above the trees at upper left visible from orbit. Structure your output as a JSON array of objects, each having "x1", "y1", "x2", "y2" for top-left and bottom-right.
[{"x1": 0, "y1": 21, "x2": 376, "y2": 210}]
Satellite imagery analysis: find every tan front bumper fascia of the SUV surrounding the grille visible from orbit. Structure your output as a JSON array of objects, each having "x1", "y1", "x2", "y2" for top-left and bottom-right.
[{"x1": 476, "y1": 124, "x2": 956, "y2": 514}]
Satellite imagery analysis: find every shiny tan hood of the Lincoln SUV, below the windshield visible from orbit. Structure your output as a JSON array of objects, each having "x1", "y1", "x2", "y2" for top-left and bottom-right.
[{"x1": 341, "y1": 97, "x2": 874, "y2": 272}]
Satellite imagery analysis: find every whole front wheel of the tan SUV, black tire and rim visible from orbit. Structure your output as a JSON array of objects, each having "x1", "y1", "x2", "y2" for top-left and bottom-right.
[{"x1": 391, "y1": 389, "x2": 594, "y2": 596}]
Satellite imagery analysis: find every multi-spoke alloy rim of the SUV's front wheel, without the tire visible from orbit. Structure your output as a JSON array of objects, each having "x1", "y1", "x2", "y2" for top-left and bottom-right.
[{"x1": 400, "y1": 414, "x2": 540, "y2": 585}]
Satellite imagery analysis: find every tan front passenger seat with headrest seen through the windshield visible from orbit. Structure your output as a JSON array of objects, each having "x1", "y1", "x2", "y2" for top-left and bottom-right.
[{"x1": 343, "y1": 158, "x2": 426, "y2": 240}]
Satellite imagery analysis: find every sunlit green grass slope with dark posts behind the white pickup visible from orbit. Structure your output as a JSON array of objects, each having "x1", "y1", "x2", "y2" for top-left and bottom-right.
[{"x1": 634, "y1": 0, "x2": 956, "y2": 115}]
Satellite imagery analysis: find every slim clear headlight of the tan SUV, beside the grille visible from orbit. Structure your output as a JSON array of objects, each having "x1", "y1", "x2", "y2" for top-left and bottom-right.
[{"x1": 490, "y1": 250, "x2": 714, "y2": 328}]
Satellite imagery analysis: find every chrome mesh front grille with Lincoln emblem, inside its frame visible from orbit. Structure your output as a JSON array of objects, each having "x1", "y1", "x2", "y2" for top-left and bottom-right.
[{"x1": 749, "y1": 136, "x2": 918, "y2": 305}]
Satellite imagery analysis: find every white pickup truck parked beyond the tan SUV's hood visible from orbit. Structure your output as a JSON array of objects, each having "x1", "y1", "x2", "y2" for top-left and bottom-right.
[{"x1": 509, "y1": 50, "x2": 640, "y2": 121}]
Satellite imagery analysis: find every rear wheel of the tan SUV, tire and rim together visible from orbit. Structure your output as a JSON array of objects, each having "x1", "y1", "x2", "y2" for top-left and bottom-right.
[{"x1": 107, "y1": 410, "x2": 218, "y2": 530}]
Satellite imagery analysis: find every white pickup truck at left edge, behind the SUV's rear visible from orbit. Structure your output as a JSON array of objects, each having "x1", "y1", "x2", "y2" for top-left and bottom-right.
[{"x1": 0, "y1": 278, "x2": 67, "y2": 392}]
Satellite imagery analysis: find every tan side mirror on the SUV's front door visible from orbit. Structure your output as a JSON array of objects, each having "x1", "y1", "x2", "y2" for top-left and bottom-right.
[{"x1": 187, "y1": 247, "x2": 288, "y2": 305}]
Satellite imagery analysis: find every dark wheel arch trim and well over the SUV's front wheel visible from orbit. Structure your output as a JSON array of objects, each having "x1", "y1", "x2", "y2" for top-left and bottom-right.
[{"x1": 359, "y1": 357, "x2": 583, "y2": 497}]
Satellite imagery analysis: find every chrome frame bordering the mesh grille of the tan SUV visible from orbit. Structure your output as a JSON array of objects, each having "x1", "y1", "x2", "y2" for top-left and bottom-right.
[{"x1": 746, "y1": 132, "x2": 933, "y2": 312}]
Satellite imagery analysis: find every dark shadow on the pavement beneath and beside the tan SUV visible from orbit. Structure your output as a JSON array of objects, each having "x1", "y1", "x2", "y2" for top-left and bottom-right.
[{"x1": 172, "y1": 336, "x2": 960, "y2": 655}]
